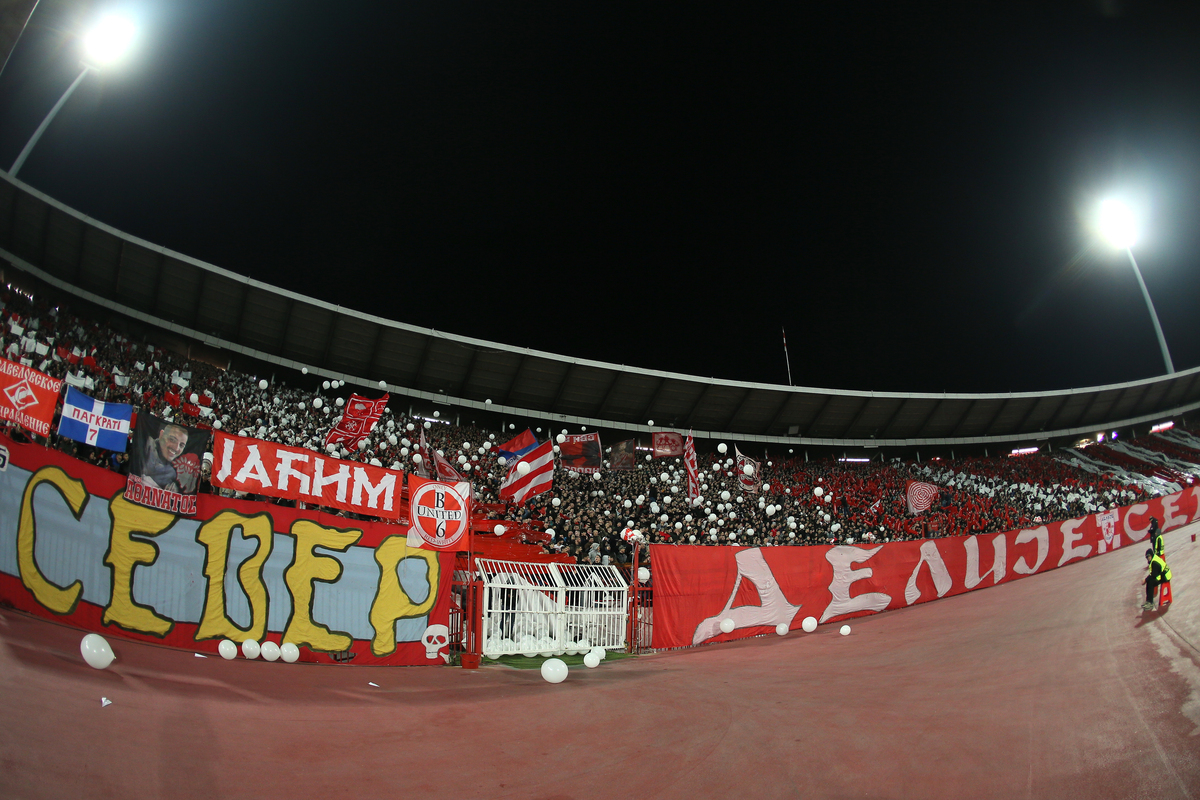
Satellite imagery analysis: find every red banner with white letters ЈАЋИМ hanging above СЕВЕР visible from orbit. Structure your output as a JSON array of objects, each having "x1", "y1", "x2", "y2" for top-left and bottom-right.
[{"x1": 212, "y1": 431, "x2": 404, "y2": 519}]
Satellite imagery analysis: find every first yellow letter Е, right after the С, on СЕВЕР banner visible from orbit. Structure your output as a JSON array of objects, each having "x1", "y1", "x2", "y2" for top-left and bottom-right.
[{"x1": 103, "y1": 494, "x2": 175, "y2": 636}]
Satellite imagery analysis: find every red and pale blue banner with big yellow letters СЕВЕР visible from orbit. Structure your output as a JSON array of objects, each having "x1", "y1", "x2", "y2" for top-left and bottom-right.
[{"x1": 0, "y1": 437, "x2": 455, "y2": 668}]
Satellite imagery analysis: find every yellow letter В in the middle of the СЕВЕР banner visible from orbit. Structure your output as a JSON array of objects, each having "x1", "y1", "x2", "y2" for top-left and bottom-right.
[{"x1": 196, "y1": 511, "x2": 275, "y2": 642}]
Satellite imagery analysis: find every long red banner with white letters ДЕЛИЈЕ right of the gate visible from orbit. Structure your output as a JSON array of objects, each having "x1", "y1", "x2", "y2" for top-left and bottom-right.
[{"x1": 650, "y1": 487, "x2": 1200, "y2": 648}]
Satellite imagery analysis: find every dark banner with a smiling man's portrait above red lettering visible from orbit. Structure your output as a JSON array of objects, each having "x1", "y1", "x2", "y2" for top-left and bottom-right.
[{"x1": 125, "y1": 414, "x2": 209, "y2": 517}]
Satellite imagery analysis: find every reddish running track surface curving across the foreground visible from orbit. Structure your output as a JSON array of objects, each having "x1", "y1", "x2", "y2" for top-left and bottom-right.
[{"x1": 0, "y1": 524, "x2": 1200, "y2": 800}]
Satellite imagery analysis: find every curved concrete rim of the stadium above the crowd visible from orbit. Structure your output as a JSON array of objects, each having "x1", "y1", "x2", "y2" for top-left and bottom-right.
[{"x1": 0, "y1": 173, "x2": 1200, "y2": 447}]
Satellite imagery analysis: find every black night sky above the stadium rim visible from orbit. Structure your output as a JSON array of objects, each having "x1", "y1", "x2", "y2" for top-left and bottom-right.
[{"x1": 0, "y1": 0, "x2": 1200, "y2": 392}]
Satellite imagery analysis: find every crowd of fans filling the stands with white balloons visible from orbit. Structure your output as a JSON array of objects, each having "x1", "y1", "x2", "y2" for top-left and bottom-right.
[{"x1": 0, "y1": 288, "x2": 1200, "y2": 563}]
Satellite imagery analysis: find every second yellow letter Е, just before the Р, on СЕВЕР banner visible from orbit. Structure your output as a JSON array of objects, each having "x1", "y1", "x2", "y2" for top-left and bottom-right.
[{"x1": 283, "y1": 519, "x2": 362, "y2": 652}]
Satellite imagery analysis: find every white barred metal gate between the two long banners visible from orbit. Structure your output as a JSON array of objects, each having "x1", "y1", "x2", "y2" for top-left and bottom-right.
[{"x1": 475, "y1": 559, "x2": 629, "y2": 656}]
